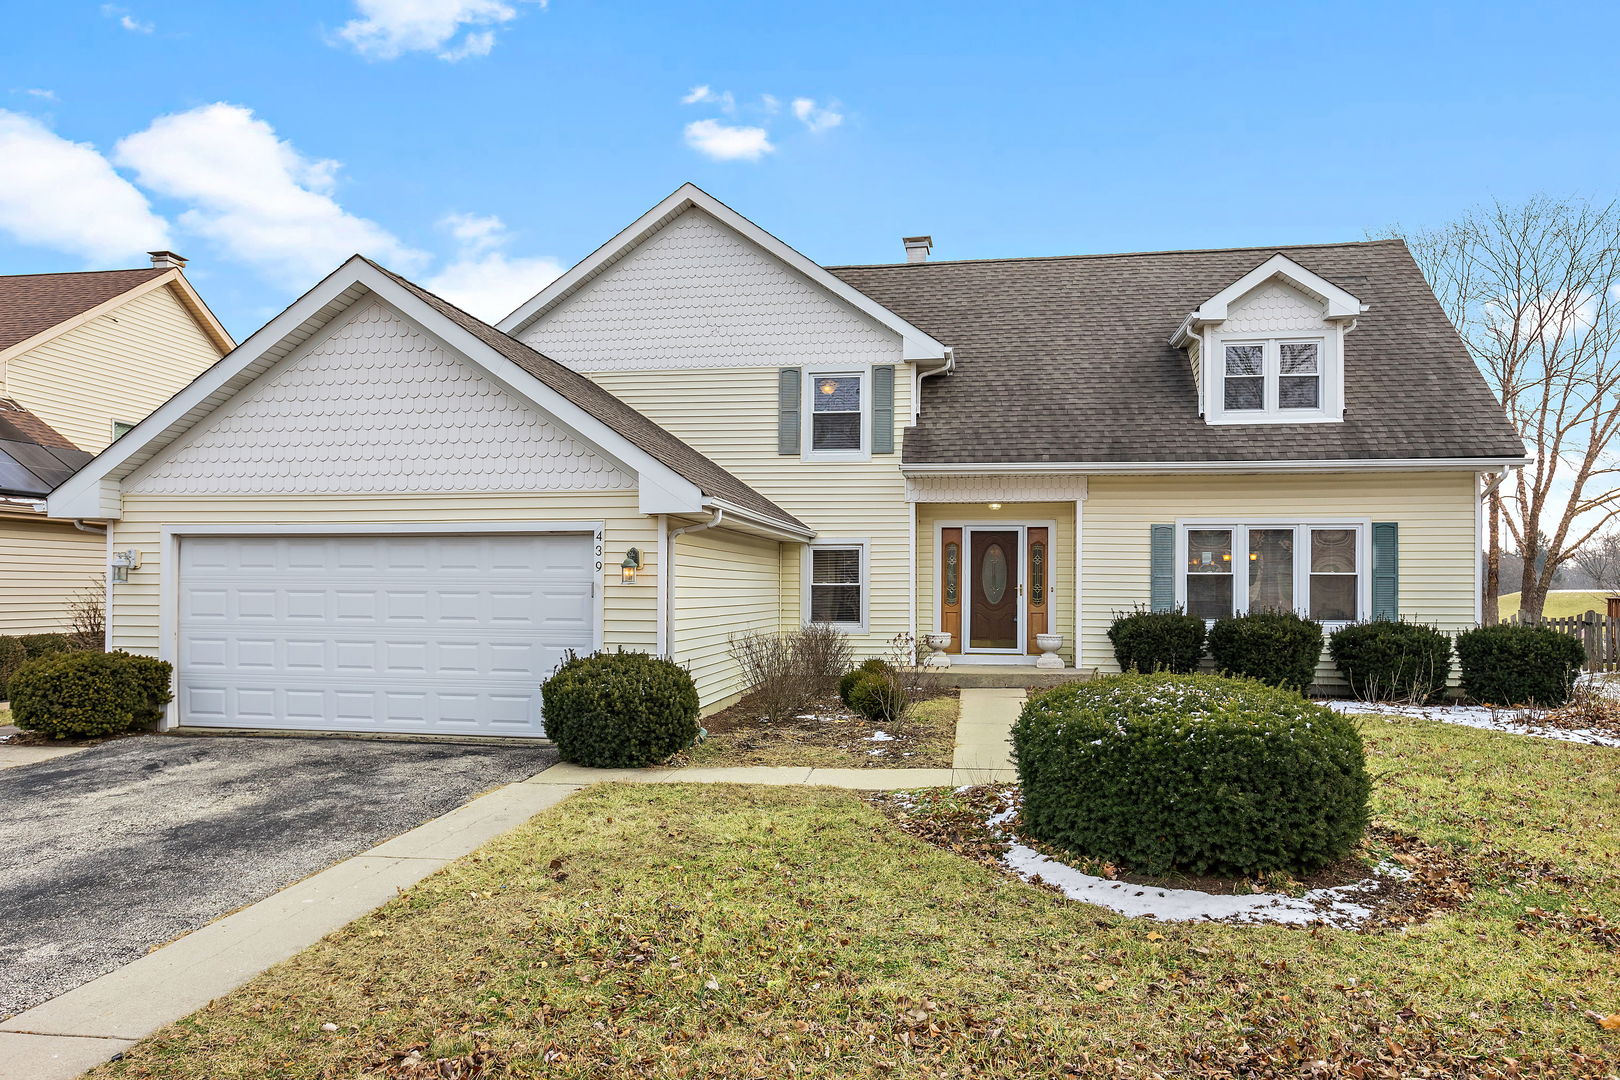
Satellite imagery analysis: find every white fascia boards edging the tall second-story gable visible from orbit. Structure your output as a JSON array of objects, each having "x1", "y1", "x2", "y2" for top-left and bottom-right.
[{"x1": 496, "y1": 183, "x2": 946, "y2": 363}]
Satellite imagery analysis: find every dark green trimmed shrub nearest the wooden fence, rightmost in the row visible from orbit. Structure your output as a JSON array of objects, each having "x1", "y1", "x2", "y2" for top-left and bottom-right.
[{"x1": 1456, "y1": 623, "x2": 1586, "y2": 708}]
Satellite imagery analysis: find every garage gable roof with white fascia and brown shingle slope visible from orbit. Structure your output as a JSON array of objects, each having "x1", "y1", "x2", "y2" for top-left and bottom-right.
[{"x1": 50, "y1": 256, "x2": 813, "y2": 538}]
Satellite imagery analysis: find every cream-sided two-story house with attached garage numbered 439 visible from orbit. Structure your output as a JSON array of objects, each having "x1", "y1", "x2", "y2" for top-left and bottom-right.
[{"x1": 50, "y1": 186, "x2": 1524, "y2": 735}]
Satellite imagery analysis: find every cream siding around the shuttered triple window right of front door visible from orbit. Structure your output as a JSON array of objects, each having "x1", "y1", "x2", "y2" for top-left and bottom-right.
[{"x1": 1081, "y1": 471, "x2": 1479, "y2": 682}]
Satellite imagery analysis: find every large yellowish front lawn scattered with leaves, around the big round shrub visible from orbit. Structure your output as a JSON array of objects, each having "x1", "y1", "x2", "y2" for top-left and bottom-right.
[{"x1": 92, "y1": 719, "x2": 1620, "y2": 1080}]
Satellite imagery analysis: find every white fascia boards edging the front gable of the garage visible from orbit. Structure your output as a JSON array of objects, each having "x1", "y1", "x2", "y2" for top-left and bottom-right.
[{"x1": 49, "y1": 256, "x2": 703, "y2": 520}]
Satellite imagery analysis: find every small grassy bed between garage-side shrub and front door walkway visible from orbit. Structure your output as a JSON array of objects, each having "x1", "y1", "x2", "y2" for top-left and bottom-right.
[{"x1": 674, "y1": 695, "x2": 961, "y2": 769}]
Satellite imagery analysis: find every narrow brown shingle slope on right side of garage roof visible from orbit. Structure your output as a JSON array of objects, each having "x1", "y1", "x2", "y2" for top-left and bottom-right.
[{"x1": 366, "y1": 259, "x2": 808, "y2": 529}]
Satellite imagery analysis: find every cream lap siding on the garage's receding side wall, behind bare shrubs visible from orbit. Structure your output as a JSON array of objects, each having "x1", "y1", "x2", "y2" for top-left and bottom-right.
[{"x1": 674, "y1": 529, "x2": 781, "y2": 711}]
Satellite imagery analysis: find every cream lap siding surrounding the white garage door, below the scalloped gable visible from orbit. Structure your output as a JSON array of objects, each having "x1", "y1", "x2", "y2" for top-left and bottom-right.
[{"x1": 112, "y1": 491, "x2": 663, "y2": 657}]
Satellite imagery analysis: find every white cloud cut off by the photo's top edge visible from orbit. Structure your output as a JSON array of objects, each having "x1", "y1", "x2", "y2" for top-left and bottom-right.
[{"x1": 337, "y1": 0, "x2": 546, "y2": 60}]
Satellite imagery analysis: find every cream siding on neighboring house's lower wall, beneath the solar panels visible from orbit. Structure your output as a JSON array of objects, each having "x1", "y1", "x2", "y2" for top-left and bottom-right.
[{"x1": 0, "y1": 517, "x2": 107, "y2": 635}]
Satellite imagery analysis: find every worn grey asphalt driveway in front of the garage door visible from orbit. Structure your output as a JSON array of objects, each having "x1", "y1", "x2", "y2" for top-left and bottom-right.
[{"x1": 0, "y1": 737, "x2": 556, "y2": 1018}]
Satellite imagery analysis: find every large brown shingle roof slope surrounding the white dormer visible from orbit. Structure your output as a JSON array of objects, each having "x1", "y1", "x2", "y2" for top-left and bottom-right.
[{"x1": 829, "y1": 240, "x2": 1524, "y2": 463}]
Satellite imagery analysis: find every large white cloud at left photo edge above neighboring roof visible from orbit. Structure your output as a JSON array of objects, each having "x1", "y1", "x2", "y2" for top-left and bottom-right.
[{"x1": 0, "y1": 108, "x2": 168, "y2": 264}]
